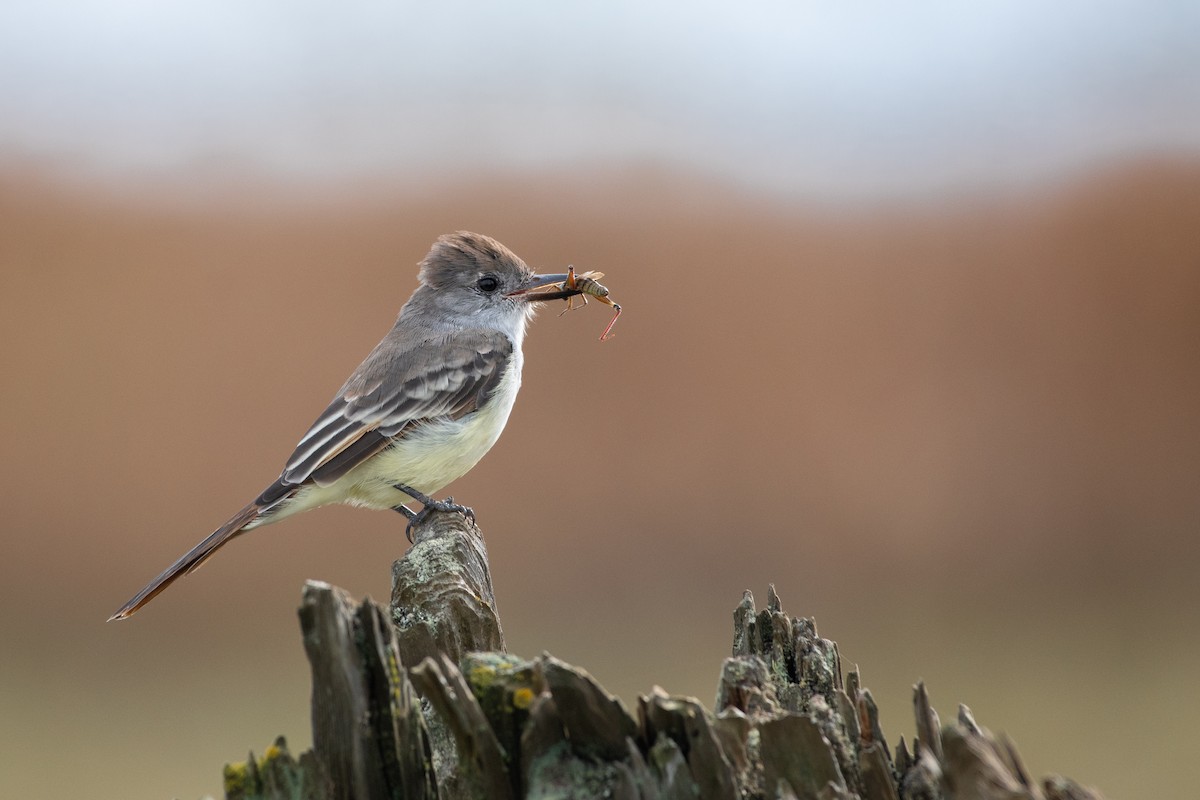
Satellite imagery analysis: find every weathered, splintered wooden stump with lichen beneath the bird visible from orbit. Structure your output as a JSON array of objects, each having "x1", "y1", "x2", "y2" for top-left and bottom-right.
[{"x1": 226, "y1": 513, "x2": 1099, "y2": 800}]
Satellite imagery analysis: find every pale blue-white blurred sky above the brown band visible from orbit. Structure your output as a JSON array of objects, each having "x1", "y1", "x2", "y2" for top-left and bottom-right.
[{"x1": 0, "y1": 0, "x2": 1200, "y2": 200}]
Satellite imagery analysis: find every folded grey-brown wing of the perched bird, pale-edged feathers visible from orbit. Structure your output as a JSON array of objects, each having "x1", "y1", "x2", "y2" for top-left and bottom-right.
[{"x1": 258, "y1": 330, "x2": 512, "y2": 505}]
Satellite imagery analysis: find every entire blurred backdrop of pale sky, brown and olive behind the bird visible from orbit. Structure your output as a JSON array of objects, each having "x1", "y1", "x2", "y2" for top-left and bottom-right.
[{"x1": 0, "y1": 0, "x2": 1200, "y2": 799}]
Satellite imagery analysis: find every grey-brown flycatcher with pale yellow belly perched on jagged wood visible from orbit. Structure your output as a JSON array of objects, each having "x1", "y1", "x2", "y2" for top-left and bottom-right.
[{"x1": 109, "y1": 231, "x2": 578, "y2": 621}]
